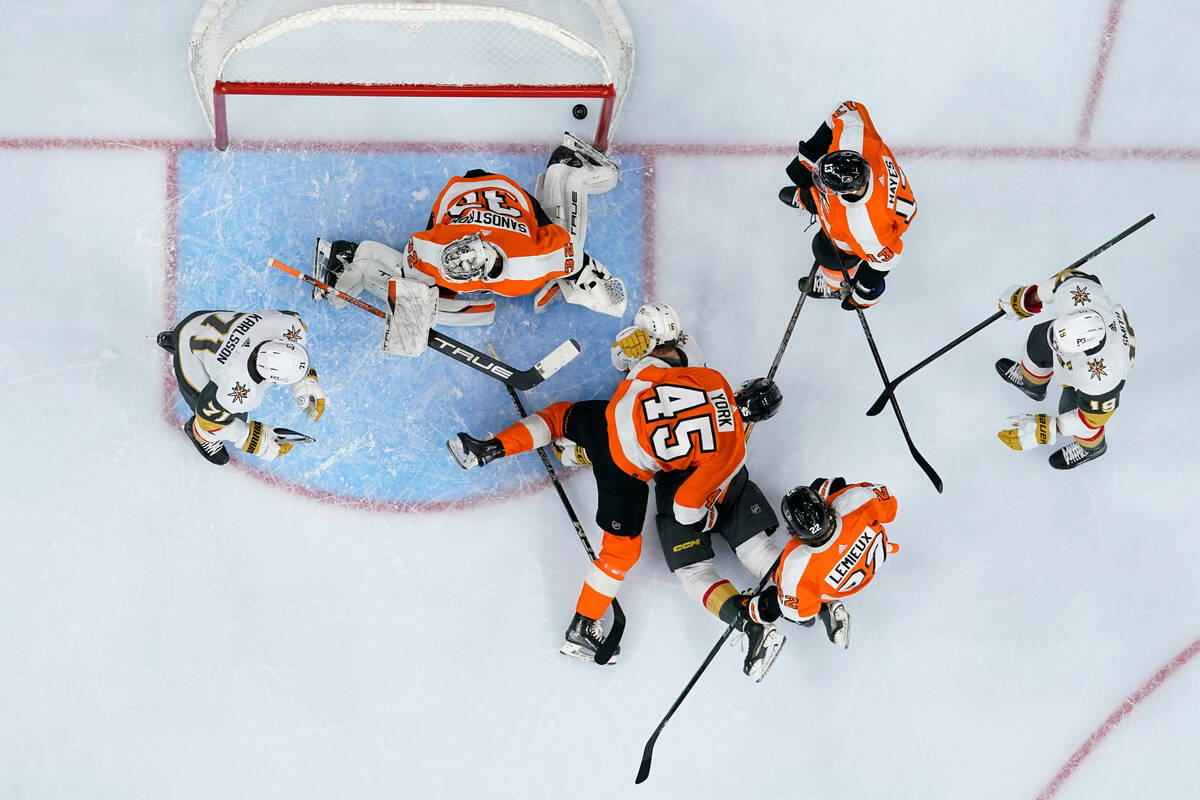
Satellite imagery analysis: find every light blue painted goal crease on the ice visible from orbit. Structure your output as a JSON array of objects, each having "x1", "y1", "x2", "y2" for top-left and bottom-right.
[{"x1": 176, "y1": 150, "x2": 646, "y2": 505}]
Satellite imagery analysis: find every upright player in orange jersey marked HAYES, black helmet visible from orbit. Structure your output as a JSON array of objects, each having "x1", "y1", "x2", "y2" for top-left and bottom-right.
[{"x1": 779, "y1": 100, "x2": 917, "y2": 309}]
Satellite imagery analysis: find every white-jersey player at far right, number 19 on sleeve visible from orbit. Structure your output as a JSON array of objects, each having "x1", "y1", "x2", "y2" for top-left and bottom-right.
[{"x1": 996, "y1": 270, "x2": 1136, "y2": 469}]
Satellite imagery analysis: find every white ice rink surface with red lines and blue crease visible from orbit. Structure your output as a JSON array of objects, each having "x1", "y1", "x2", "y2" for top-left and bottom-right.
[{"x1": 0, "y1": 0, "x2": 1200, "y2": 800}]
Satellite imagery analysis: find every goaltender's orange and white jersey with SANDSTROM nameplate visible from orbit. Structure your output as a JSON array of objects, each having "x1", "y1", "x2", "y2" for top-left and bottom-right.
[{"x1": 404, "y1": 170, "x2": 576, "y2": 297}]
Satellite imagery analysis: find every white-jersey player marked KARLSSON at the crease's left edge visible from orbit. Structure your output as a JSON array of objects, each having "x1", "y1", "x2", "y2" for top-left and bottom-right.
[{"x1": 157, "y1": 311, "x2": 325, "y2": 464}]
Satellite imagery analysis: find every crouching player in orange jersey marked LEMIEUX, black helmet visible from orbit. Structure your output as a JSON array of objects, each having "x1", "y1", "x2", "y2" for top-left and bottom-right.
[{"x1": 750, "y1": 477, "x2": 900, "y2": 648}]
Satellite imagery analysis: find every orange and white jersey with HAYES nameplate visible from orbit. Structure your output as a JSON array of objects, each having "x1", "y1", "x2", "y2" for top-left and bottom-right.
[{"x1": 800, "y1": 100, "x2": 917, "y2": 272}]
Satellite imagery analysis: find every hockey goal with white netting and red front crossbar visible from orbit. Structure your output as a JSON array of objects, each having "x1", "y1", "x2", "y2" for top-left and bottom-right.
[{"x1": 188, "y1": 0, "x2": 634, "y2": 150}]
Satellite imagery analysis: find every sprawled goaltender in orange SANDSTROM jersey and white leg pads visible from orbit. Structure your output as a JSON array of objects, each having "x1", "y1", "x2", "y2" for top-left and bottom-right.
[{"x1": 313, "y1": 134, "x2": 625, "y2": 355}]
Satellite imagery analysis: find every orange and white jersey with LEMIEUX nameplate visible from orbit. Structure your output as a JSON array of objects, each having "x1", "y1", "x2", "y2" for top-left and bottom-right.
[{"x1": 774, "y1": 481, "x2": 900, "y2": 621}]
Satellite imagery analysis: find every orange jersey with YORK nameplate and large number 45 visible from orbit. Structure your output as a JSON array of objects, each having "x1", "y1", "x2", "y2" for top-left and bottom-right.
[{"x1": 606, "y1": 357, "x2": 746, "y2": 525}]
